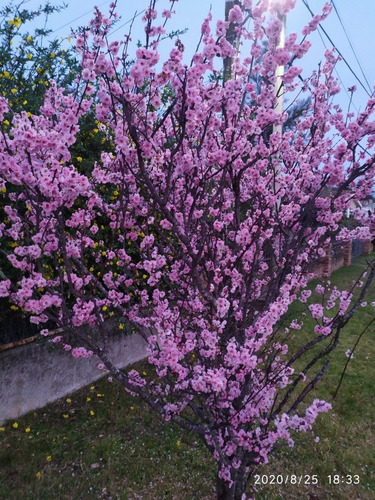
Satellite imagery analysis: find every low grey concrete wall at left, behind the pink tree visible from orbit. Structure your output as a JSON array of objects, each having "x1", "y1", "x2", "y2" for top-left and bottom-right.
[{"x1": 0, "y1": 335, "x2": 146, "y2": 425}]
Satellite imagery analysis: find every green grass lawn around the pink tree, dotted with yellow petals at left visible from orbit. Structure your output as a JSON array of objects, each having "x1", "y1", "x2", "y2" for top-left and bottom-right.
[{"x1": 0, "y1": 258, "x2": 375, "y2": 500}]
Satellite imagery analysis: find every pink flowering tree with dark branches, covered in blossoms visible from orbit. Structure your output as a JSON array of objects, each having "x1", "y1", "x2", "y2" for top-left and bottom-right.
[{"x1": 0, "y1": 0, "x2": 375, "y2": 499}]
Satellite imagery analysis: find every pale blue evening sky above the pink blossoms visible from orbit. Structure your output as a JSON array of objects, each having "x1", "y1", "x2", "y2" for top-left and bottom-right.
[{"x1": 11, "y1": 0, "x2": 375, "y2": 111}]
